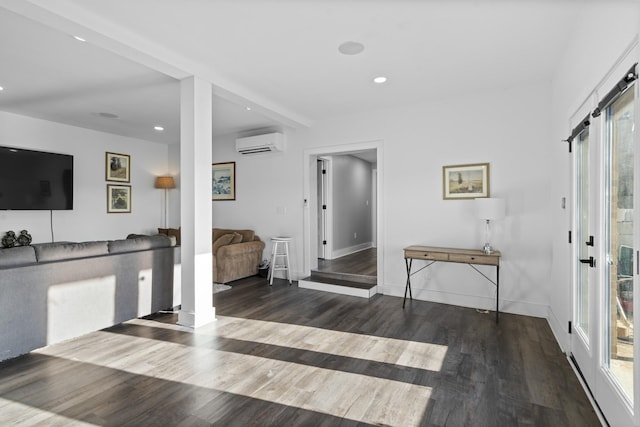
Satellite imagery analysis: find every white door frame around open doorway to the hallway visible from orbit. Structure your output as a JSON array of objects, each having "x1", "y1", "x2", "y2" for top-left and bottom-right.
[{"x1": 302, "y1": 140, "x2": 384, "y2": 289}]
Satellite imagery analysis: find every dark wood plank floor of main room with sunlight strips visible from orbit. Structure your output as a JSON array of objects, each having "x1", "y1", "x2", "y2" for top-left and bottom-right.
[{"x1": 0, "y1": 277, "x2": 600, "y2": 427}]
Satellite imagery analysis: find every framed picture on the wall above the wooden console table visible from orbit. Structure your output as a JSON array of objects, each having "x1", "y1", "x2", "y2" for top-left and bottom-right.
[{"x1": 442, "y1": 163, "x2": 489, "y2": 200}]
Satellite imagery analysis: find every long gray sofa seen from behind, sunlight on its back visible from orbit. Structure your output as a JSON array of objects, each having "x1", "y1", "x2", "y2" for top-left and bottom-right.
[{"x1": 0, "y1": 235, "x2": 180, "y2": 360}]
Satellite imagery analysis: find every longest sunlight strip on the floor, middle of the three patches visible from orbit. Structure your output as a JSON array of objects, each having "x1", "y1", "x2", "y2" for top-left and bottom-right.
[{"x1": 38, "y1": 328, "x2": 432, "y2": 426}]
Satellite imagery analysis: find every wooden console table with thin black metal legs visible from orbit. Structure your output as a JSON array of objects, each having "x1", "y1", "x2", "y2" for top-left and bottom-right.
[{"x1": 402, "y1": 246, "x2": 501, "y2": 323}]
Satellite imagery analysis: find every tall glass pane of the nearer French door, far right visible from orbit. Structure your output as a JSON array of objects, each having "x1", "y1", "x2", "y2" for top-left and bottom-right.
[{"x1": 603, "y1": 84, "x2": 637, "y2": 405}]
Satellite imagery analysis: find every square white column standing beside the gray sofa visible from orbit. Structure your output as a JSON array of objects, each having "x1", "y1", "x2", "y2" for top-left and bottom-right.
[{"x1": 178, "y1": 77, "x2": 215, "y2": 328}]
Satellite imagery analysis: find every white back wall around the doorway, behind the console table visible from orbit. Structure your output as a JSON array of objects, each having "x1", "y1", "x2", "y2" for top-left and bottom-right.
[{"x1": 213, "y1": 82, "x2": 551, "y2": 316}]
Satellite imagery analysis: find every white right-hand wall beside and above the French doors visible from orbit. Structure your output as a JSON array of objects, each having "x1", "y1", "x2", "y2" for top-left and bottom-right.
[{"x1": 547, "y1": 2, "x2": 640, "y2": 350}]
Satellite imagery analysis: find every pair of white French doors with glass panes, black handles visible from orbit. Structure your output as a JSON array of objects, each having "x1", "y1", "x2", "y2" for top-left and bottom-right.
[{"x1": 571, "y1": 68, "x2": 640, "y2": 425}]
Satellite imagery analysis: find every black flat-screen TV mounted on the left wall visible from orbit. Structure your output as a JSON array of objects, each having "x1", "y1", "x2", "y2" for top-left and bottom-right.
[{"x1": 0, "y1": 147, "x2": 73, "y2": 210}]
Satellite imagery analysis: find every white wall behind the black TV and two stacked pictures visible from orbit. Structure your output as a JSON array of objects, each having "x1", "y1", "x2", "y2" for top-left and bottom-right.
[{"x1": 0, "y1": 112, "x2": 168, "y2": 243}]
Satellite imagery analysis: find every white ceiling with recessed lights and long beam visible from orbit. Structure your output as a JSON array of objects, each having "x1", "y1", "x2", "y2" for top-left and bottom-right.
[{"x1": 0, "y1": 0, "x2": 615, "y2": 143}]
